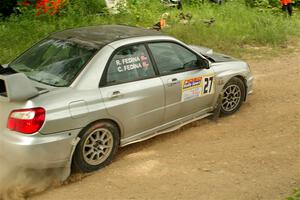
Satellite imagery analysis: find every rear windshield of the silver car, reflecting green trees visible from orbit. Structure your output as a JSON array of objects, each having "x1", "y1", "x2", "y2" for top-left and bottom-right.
[{"x1": 9, "y1": 39, "x2": 97, "y2": 87}]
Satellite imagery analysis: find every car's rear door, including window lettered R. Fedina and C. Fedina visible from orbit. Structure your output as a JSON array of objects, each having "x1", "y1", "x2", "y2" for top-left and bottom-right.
[{"x1": 100, "y1": 44, "x2": 165, "y2": 137}]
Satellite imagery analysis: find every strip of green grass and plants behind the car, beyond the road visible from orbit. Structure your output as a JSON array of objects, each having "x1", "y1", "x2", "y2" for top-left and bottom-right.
[{"x1": 0, "y1": 0, "x2": 300, "y2": 63}]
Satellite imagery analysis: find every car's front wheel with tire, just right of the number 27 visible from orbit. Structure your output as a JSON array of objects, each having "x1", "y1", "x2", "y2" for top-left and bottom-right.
[{"x1": 220, "y1": 77, "x2": 246, "y2": 116}]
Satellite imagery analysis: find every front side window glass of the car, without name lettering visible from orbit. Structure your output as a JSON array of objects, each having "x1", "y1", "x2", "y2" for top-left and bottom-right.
[{"x1": 149, "y1": 42, "x2": 198, "y2": 75}]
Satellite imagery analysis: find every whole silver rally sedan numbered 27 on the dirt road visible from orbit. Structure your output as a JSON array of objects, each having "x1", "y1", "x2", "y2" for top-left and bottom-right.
[{"x1": 0, "y1": 25, "x2": 253, "y2": 172}]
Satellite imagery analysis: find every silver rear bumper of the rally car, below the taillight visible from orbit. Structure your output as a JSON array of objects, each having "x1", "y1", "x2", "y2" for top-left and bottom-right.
[{"x1": 0, "y1": 129, "x2": 80, "y2": 169}]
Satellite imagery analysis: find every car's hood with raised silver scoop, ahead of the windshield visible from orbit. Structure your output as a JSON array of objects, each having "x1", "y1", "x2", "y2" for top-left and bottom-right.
[{"x1": 189, "y1": 45, "x2": 237, "y2": 63}]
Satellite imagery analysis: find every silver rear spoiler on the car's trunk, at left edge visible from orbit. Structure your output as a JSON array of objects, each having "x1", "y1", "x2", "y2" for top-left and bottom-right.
[{"x1": 0, "y1": 73, "x2": 39, "y2": 102}]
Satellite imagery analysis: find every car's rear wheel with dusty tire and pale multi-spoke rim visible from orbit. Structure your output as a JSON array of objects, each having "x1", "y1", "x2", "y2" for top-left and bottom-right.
[{"x1": 72, "y1": 121, "x2": 120, "y2": 172}]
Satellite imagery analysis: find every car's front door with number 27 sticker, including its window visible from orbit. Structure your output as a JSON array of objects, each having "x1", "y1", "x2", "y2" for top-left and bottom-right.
[{"x1": 148, "y1": 42, "x2": 215, "y2": 121}]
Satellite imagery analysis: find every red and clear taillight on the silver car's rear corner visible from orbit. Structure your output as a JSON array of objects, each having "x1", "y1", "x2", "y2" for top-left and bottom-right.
[{"x1": 7, "y1": 107, "x2": 46, "y2": 134}]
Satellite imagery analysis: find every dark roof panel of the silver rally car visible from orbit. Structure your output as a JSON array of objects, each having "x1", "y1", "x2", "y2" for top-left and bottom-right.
[{"x1": 51, "y1": 25, "x2": 163, "y2": 48}]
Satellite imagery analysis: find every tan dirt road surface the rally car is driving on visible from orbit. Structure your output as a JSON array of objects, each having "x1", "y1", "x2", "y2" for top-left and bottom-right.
[{"x1": 30, "y1": 51, "x2": 300, "y2": 200}]
